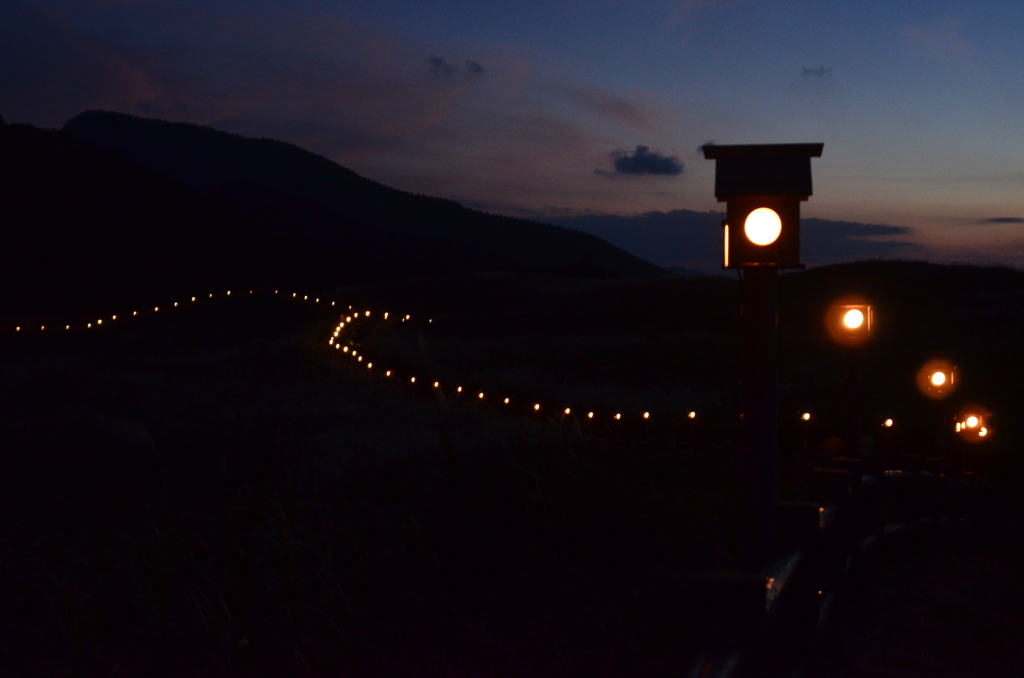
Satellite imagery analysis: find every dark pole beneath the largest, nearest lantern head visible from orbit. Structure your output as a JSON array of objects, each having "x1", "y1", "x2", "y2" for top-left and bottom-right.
[{"x1": 740, "y1": 266, "x2": 778, "y2": 568}]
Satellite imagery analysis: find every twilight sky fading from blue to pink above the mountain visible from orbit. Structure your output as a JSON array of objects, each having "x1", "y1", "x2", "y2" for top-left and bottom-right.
[{"x1": 6, "y1": 0, "x2": 1024, "y2": 265}]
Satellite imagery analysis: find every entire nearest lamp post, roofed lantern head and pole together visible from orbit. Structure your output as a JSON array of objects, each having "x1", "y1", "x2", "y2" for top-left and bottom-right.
[{"x1": 703, "y1": 143, "x2": 824, "y2": 567}]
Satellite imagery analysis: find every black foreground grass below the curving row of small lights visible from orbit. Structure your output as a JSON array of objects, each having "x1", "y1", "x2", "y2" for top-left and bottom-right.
[{"x1": 0, "y1": 302, "x2": 738, "y2": 676}]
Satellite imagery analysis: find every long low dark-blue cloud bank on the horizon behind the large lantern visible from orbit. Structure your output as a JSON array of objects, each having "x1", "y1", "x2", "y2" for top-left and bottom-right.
[{"x1": 540, "y1": 210, "x2": 925, "y2": 272}]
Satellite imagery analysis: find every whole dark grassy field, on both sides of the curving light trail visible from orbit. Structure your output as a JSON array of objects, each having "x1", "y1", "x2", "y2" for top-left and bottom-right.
[{"x1": 0, "y1": 264, "x2": 1024, "y2": 676}]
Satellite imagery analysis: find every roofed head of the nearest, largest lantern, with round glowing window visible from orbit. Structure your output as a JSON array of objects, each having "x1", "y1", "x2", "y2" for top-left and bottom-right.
[{"x1": 703, "y1": 143, "x2": 824, "y2": 268}]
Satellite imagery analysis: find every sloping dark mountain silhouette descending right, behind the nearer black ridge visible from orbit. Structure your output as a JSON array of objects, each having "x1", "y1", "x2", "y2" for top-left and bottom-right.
[{"x1": 62, "y1": 111, "x2": 667, "y2": 280}]
